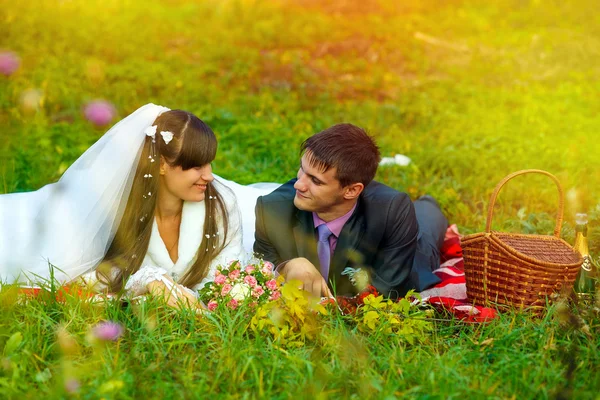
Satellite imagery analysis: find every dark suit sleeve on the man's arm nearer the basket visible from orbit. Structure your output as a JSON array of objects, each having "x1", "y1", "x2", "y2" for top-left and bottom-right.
[{"x1": 371, "y1": 193, "x2": 419, "y2": 298}]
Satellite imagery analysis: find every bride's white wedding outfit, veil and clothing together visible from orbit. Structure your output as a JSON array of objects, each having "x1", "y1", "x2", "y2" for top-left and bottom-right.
[{"x1": 0, "y1": 104, "x2": 278, "y2": 293}]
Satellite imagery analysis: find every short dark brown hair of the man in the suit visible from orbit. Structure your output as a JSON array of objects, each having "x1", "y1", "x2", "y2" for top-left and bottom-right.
[{"x1": 300, "y1": 124, "x2": 381, "y2": 187}]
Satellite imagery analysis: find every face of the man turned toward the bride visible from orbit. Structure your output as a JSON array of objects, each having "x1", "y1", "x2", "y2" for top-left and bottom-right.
[{"x1": 294, "y1": 154, "x2": 344, "y2": 213}]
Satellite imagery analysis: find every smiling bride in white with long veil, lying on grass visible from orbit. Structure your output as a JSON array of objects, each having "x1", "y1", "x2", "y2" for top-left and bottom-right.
[{"x1": 0, "y1": 104, "x2": 277, "y2": 306}]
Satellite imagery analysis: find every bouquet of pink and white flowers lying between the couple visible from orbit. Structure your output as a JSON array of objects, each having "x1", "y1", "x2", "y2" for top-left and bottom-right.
[{"x1": 199, "y1": 260, "x2": 281, "y2": 311}]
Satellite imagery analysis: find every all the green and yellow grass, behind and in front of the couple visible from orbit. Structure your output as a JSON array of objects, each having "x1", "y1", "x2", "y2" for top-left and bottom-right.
[{"x1": 0, "y1": 0, "x2": 600, "y2": 398}]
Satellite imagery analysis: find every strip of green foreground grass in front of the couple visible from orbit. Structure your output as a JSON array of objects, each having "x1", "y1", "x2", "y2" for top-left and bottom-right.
[{"x1": 0, "y1": 290, "x2": 600, "y2": 399}]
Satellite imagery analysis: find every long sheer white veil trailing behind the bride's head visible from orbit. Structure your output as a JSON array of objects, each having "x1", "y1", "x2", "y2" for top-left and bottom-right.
[{"x1": 0, "y1": 104, "x2": 169, "y2": 283}]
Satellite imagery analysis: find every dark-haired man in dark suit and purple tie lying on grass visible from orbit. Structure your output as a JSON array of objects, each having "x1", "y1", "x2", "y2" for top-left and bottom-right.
[{"x1": 254, "y1": 124, "x2": 448, "y2": 298}]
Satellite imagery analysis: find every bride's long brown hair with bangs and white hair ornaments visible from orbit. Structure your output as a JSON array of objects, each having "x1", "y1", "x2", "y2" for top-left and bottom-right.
[{"x1": 96, "y1": 110, "x2": 229, "y2": 292}]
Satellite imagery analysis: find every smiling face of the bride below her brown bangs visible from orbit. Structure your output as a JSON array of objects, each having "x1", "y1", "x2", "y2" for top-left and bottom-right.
[{"x1": 160, "y1": 163, "x2": 215, "y2": 202}]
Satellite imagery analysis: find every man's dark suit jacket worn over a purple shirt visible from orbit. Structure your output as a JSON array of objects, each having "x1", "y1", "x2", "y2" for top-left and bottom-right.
[{"x1": 254, "y1": 179, "x2": 419, "y2": 298}]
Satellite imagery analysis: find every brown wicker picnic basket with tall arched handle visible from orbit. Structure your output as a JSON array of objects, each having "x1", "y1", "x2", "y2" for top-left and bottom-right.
[{"x1": 462, "y1": 169, "x2": 583, "y2": 307}]
